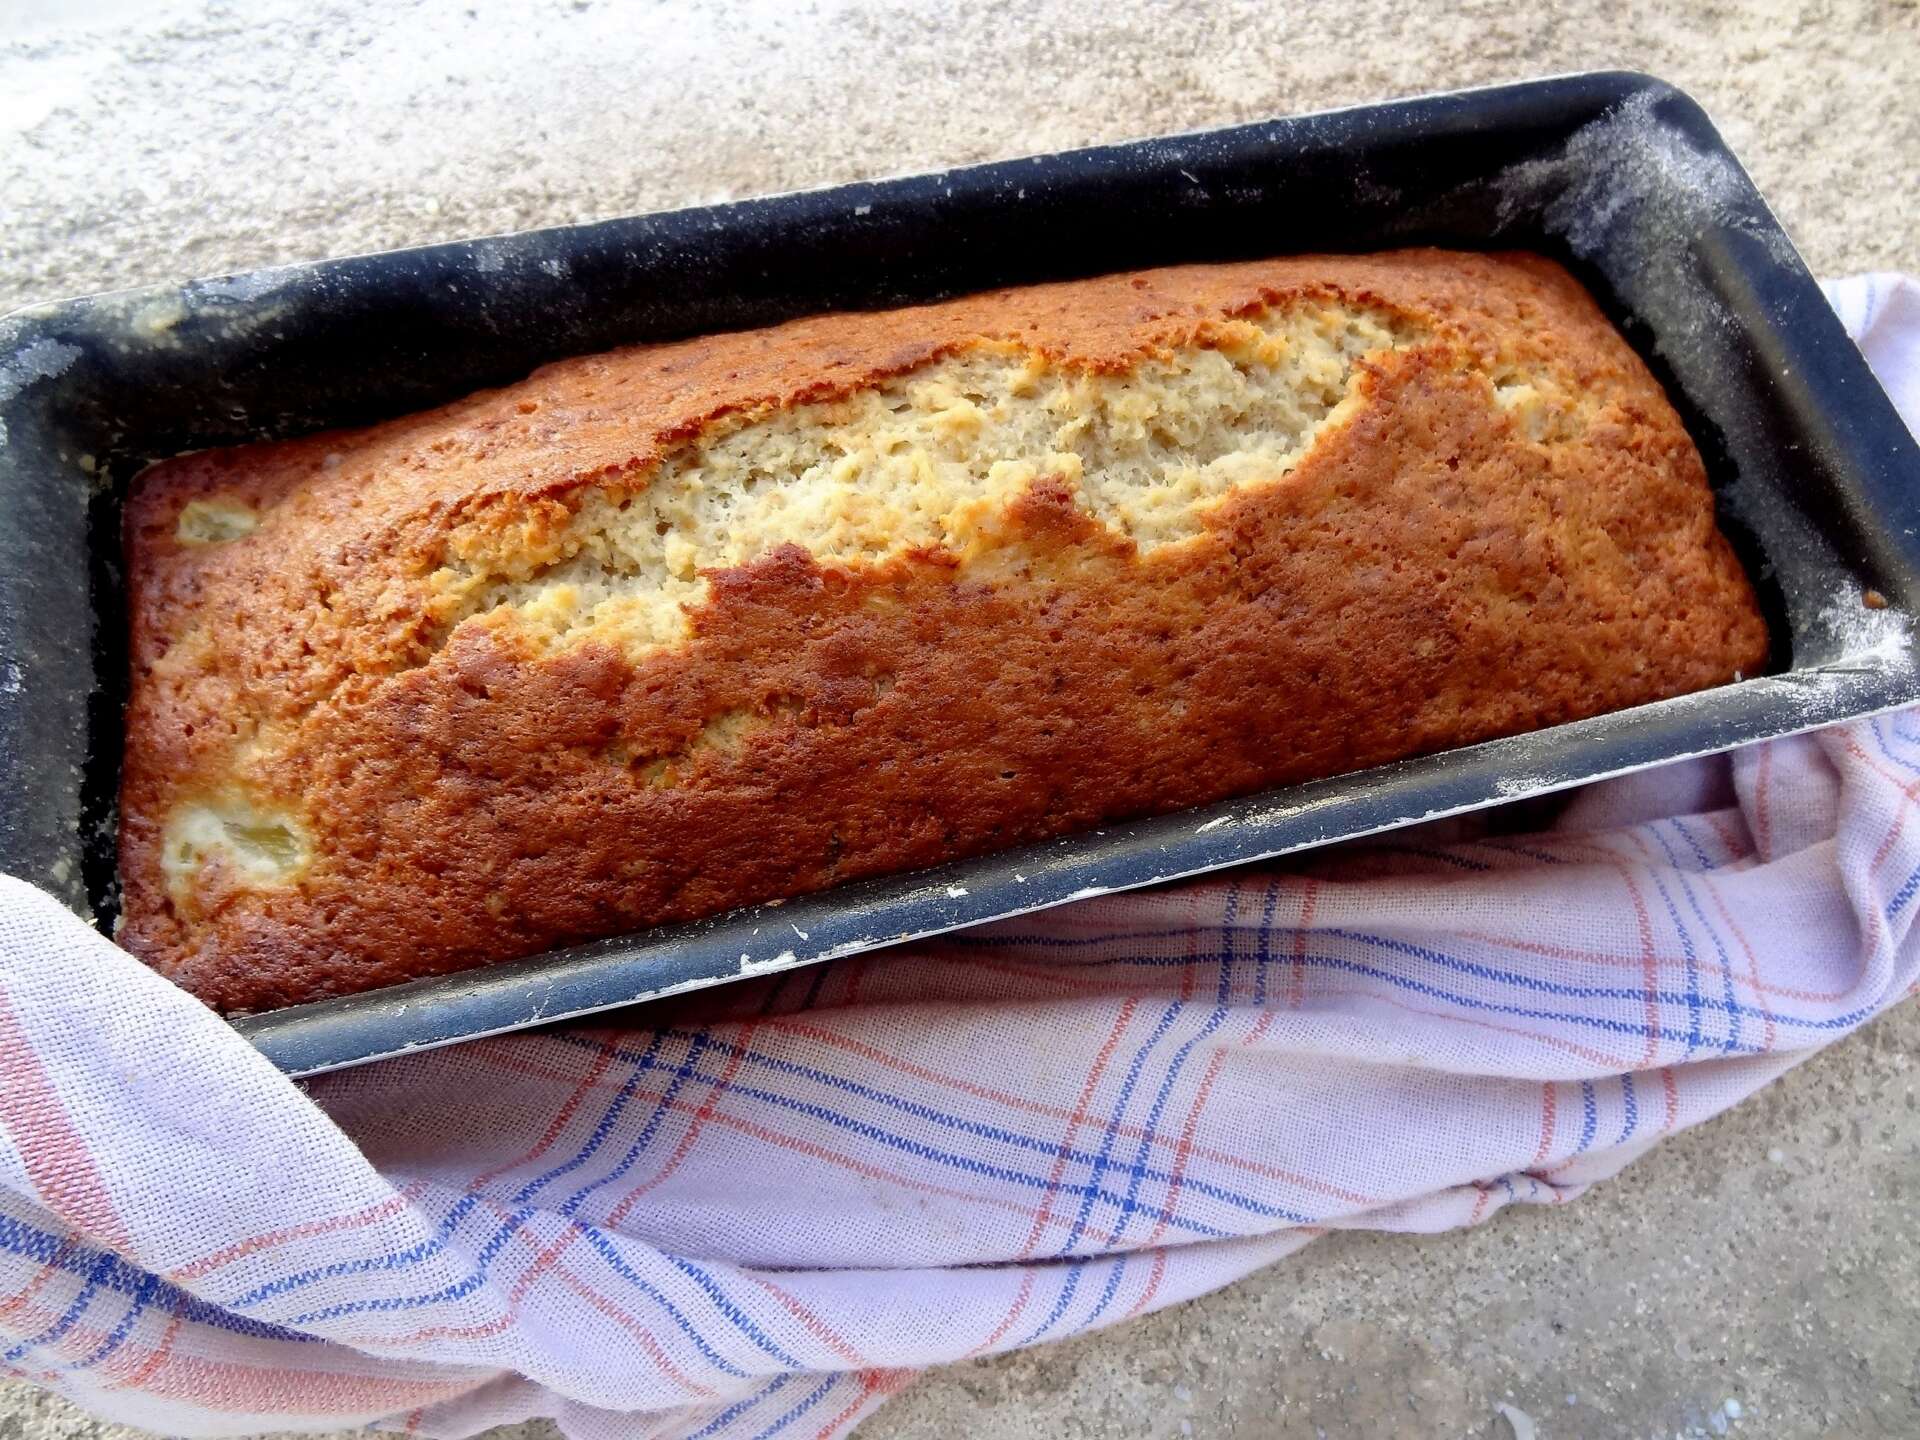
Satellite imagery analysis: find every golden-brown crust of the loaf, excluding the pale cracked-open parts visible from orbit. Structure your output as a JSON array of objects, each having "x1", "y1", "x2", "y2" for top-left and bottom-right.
[{"x1": 121, "y1": 252, "x2": 1766, "y2": 1010}]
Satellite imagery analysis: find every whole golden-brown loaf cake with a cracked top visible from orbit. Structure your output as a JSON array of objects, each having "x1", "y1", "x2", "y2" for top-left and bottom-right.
[{"x1": 121, "y1": 250, "x2": 1766, "y2": 1012}]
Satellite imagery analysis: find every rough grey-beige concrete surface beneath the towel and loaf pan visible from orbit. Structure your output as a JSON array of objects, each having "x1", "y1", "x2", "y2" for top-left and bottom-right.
[{"x1": 0, "y1": 0, "x2": 1920, "y2": 1440}]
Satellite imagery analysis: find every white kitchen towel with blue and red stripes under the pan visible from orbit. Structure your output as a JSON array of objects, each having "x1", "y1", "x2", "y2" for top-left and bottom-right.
[{"x1": 0, "y1": 276, "x2": 1920, "y2": 1440}]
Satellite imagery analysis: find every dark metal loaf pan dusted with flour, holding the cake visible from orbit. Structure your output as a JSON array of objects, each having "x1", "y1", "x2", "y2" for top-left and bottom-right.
[{"x1": 0, "y1": 73, "x2": 1920, "y2": 1073}]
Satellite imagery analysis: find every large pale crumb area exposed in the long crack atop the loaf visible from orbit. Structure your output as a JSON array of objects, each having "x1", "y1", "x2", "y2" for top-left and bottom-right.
[{"x1": 430, "y1": 301, "x2": 1421, "y2": 655}]
